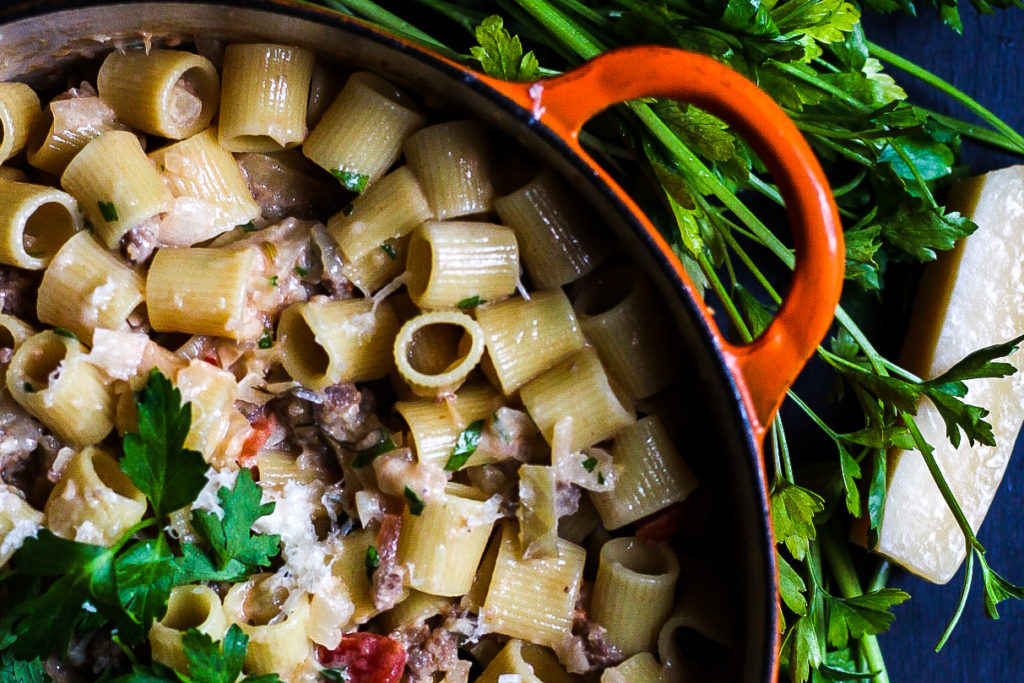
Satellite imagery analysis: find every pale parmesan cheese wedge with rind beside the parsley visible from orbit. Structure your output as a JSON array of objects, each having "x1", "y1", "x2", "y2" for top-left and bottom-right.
[{"x1": 874, "y1": 166, "x2": 1024, "y2": 584}]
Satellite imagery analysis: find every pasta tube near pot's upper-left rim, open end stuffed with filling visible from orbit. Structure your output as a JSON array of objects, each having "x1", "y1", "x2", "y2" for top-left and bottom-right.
[{"x1": 96, "y1": 49, "x2": 220, "y2": 140}]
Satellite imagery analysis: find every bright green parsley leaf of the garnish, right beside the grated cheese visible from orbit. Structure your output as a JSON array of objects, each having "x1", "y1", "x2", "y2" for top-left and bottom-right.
[{"x1": 182, "y1": 468, "x2": 281, "y2": 572}]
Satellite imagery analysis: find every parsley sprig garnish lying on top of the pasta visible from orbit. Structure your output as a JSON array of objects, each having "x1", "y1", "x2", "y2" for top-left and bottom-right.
[{"x1": 0, "y1": 370, "x2": 280, "y2": 683}]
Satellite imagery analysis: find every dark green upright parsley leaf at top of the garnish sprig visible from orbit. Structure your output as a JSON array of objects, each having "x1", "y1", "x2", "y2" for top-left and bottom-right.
[{"x1": 121, "y1": 369, "x2": 207, "y2": 519}]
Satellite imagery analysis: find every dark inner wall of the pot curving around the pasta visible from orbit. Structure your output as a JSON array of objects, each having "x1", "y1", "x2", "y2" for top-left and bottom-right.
[{"x1": 0, "y1": 2, "x2": 777, "y2": 681}]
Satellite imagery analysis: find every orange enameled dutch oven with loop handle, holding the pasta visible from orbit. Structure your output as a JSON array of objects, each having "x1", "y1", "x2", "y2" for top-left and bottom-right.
[{"x1": 0, "y1": 0, "x2": 844, "y2": 681}]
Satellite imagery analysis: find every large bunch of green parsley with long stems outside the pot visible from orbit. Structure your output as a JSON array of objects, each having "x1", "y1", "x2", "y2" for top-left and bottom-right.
[{"x1": 299, "y1": 0, "x2": 1024, "y2": 681}]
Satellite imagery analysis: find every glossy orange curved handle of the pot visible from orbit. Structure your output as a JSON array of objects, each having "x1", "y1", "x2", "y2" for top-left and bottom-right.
[{"x1": 486, "y1": 47, "x2": 845, "y2": 435}]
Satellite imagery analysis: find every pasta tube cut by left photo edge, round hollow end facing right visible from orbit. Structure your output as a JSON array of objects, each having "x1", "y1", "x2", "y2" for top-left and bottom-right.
[{"x1": 0, "y1": 179, "x2": 82, "y2": 270}]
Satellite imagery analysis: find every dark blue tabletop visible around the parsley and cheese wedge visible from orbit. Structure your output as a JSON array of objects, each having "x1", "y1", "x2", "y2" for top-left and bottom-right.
[{"x1": 864, "y1": 7, "x2": 1024, "y2": 683}]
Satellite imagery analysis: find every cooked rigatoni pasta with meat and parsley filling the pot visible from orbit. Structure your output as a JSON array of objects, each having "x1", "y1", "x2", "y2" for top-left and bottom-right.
[{"x1": 0, "y1": 41, "x2": 704, "y2": 683}]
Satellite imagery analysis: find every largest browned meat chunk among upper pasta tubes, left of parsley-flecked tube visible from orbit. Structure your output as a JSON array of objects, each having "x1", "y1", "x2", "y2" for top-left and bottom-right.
[{"x1": 238, "y1": 151, "x2": 342, "y2": 223}]
